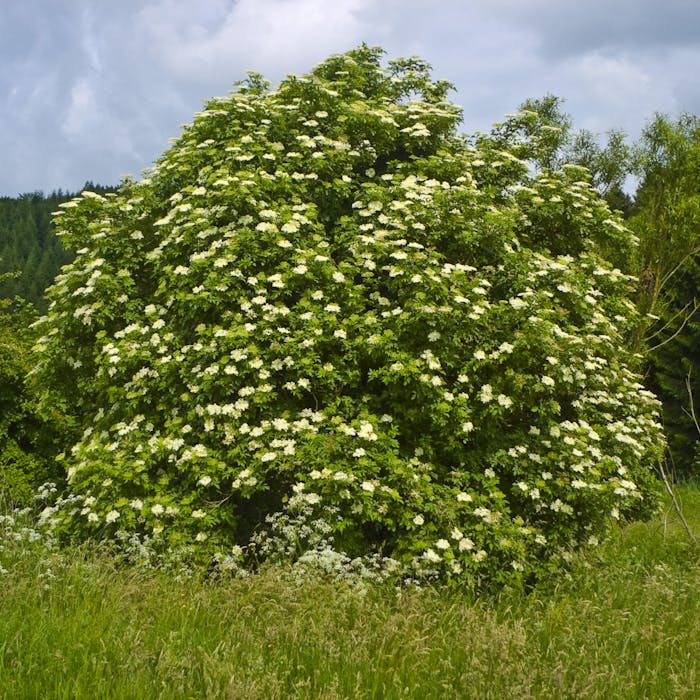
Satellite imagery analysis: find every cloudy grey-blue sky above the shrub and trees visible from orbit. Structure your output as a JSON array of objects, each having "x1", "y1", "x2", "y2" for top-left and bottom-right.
[{"x1": 0, "y1": 0, "x2": 700, "y2": 196}]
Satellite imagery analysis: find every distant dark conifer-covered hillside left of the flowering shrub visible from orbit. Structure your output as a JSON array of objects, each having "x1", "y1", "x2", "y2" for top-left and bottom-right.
[{"x1": 0, "y1": 182, "x2": 116, "y2": 312}]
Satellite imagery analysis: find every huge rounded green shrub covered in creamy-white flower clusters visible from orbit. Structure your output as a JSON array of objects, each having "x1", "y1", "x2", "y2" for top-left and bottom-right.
[{"x1": 36, "y1": 47, "x2": 663, "y2": 581}]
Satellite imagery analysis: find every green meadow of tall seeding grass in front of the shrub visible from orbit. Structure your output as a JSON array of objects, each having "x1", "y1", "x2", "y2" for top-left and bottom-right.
[{"x1": 0, "y1": 488, "x2": 700, "y2": 700}]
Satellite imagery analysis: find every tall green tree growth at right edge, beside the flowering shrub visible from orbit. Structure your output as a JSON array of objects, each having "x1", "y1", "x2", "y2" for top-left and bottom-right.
[{"x1": 629, "y1": 115, "x2": 700, "y2": 477}]
